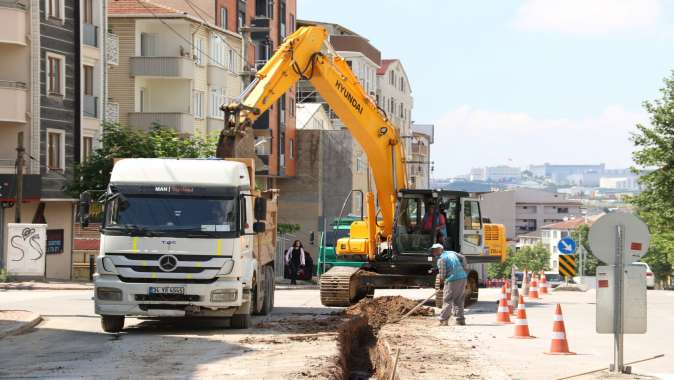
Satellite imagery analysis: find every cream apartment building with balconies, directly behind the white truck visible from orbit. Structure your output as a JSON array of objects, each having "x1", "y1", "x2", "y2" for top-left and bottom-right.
[{"x1": 108, "y1": 0, "x2": 243, "y2": 140}]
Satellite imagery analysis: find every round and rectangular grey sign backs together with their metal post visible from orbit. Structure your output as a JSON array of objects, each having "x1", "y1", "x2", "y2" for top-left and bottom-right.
[{"x1": 589, "y1": 212, "x2": 650, "y2": 373}]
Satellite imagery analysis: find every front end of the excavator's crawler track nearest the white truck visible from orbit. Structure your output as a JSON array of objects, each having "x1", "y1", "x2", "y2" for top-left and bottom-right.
[{"x1": 320, "y1": 266, "x2": 360, "y2": 306}]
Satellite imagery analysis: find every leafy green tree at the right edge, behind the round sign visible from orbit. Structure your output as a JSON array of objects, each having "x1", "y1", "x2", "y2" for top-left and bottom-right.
[{"x1": 630, "y1": 71, "x2": 674, "y2": 280}]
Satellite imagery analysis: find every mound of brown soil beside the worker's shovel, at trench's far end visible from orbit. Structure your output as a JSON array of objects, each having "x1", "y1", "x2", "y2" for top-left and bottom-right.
[{"x1": 344, "y1": 296, "x2": 433, "y2": 331}]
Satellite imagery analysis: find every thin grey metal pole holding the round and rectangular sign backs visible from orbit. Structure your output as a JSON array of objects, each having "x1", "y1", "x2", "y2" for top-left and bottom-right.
[{"x1": 611, "y1": 225, "x2": 624, "y2": 373}]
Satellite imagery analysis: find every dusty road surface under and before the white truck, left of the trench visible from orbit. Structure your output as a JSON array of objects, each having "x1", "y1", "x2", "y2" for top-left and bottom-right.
[{"x1": 0, "y1": 289, "x2": 336, "y2": 379}]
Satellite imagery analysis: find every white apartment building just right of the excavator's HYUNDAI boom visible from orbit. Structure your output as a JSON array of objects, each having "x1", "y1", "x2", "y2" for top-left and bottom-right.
[{"x1": 377, "y1": 59, "x2": 414, "y2": 163}]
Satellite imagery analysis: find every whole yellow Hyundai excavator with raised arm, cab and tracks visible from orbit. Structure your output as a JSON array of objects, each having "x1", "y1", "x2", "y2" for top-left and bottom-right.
[{"x1": 218, "y1": 26, "x2": 505, "y2": 306}]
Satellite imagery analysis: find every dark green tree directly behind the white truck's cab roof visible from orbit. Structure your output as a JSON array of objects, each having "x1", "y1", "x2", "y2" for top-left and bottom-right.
[{"x1": 65, "y1": 124, "x2": 216, "y2": 197}]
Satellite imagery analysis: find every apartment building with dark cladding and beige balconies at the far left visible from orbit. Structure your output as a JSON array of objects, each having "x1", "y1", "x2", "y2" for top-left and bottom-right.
[{"x1": 0, "y1": 0, "x2": 106, "y2": 279}]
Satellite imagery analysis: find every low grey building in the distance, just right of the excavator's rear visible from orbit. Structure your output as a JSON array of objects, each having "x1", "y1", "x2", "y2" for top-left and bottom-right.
[{"x1": 481, "y1": 189, "x2": 582, "y2": 241}]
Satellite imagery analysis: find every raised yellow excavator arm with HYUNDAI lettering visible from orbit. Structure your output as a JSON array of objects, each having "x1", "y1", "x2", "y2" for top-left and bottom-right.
[{"x1": 218, "y1": 26, "x2": 407, "y2": 249}]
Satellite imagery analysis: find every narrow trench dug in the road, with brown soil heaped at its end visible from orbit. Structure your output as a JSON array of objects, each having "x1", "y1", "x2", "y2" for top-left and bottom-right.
[{"x1": 330, "y1": 296, "x2": 433, "y2": 380}]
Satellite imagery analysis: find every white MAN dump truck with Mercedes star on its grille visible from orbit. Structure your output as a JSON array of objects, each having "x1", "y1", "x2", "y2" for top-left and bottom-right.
[{"x1": 79, "y1": 158, "x2": 277, "y2": 332}]
